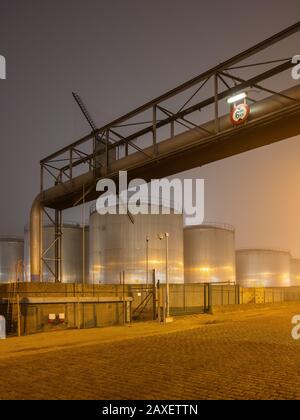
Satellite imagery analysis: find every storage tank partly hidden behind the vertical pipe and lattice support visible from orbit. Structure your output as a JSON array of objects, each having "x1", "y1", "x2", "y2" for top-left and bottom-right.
[{"x1": 24, "y1": 223, "x2": 89, "y2": 283}]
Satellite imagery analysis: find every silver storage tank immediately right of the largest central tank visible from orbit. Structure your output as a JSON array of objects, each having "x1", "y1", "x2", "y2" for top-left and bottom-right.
[{"x1": 184, "y1": 224, "x2": 235, "y2": 283}]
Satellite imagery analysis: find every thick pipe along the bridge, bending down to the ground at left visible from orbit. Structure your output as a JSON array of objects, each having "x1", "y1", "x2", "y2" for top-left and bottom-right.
[{"x1": 30, "y1": 85, "x2": 300, "y2": 281}]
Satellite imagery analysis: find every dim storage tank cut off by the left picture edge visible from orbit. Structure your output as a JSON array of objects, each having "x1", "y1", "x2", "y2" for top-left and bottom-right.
[{"x1": 0, "y1": 238, "x2": 24, "y2": 283}]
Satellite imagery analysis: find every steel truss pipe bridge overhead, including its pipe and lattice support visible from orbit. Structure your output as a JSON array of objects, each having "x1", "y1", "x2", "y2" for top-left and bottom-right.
[{"x1": 30, "y1": 22, "x2": 300, "y2": 281}]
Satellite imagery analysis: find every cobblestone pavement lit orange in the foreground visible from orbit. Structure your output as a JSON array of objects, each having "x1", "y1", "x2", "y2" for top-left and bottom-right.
[{"x1": 0, "y1": 304, "x2": 300, "y2": 399}]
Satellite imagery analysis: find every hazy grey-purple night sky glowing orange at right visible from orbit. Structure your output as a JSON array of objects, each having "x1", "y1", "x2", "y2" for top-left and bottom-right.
[{"x1": 0, "y1": 0, "x2": 300, "y2": 257}]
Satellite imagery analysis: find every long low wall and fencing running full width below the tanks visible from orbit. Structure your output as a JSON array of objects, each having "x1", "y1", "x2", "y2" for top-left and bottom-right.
[{"x1": 0, "y1": 283, "x2": 300, "y2": 334}]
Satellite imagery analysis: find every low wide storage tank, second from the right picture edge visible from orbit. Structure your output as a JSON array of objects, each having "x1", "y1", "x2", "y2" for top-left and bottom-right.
[{"x1": 236, "y1": 249, "x2": 291, "y2": 287}]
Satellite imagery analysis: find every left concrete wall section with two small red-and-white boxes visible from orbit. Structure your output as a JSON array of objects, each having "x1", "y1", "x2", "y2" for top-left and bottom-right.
[{"x1": 0, "y1": 283, "x2": 134, "y2": 334}]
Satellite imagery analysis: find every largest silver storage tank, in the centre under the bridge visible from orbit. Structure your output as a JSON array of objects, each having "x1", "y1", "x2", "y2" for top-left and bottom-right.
[{"x1": 89, "y1": 203, "x2": 184, "y2": 284}]
